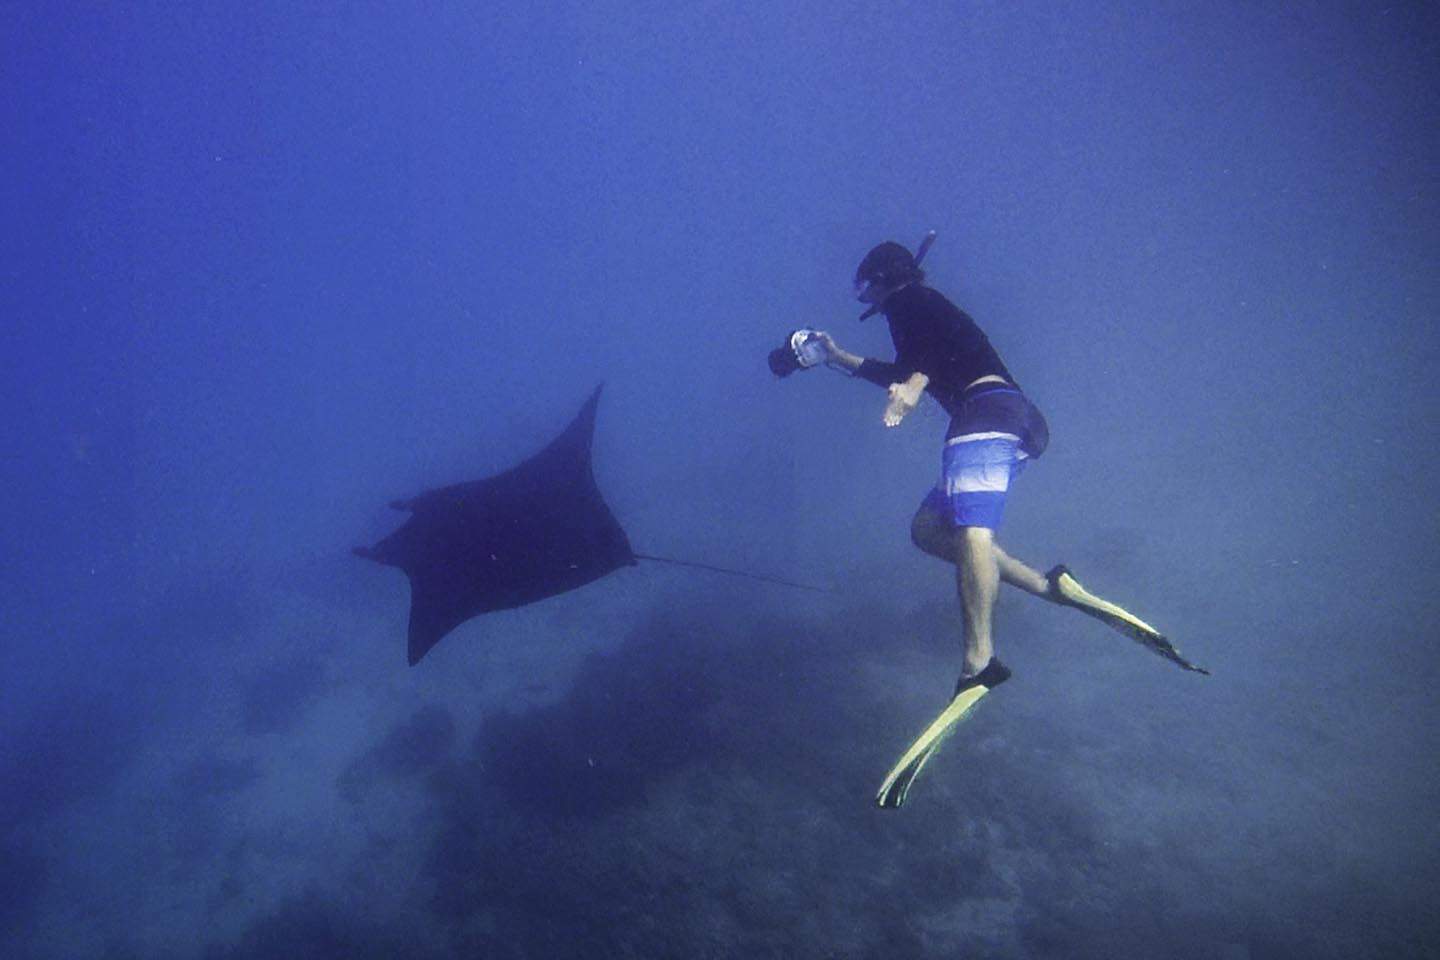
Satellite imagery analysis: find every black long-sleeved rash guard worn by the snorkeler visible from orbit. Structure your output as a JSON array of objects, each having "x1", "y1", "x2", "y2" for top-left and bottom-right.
[{"x1": 855, "y1": 284, "x2": 1015, "y2": 417}]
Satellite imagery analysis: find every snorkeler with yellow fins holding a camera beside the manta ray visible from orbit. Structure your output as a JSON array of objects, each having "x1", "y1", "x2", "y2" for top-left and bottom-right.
[{"x1": 789, "y1": 232, "x2": 1207, "y2": 807}]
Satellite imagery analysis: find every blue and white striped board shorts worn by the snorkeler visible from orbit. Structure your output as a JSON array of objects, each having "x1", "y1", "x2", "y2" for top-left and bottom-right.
[{"x1": 920, "y1": 381, "x2": 1050, "y2": 530}]
